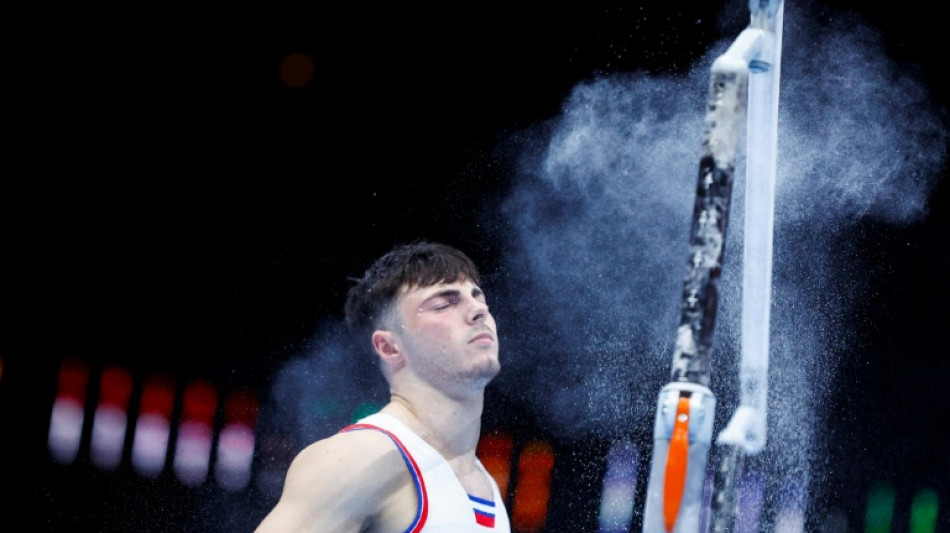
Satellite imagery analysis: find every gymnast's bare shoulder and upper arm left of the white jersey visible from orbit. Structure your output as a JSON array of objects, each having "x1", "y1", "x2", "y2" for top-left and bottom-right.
[{"x1": 255, "y1": 430, "x2": 415, "y2": 533}]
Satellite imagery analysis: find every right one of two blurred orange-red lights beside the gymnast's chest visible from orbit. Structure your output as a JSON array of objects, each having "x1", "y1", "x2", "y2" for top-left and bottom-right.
[{"x1": 511, "y1": 440, "x2": 554, "y2": 533}]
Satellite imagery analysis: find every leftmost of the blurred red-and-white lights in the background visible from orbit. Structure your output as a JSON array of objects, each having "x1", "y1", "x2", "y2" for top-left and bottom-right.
[{"x1": 47, "y1": 357, "x2": 89, "y2": 464}]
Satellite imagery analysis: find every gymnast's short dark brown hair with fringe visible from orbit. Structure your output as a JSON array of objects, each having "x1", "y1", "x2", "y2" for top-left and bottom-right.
[{"x1": 344, "y1": 240, "x2": 481, "y2": 335}]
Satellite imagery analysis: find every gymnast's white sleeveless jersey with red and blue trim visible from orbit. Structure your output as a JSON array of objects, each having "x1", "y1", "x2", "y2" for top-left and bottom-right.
[{"x1": 341, "y1": 413, "x2": 511, "y2": 533}]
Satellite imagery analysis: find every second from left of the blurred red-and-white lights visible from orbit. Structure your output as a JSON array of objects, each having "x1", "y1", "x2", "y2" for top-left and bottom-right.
[{"x1": 89, "y1": 366, "x2": 132, "y2": 470}]
